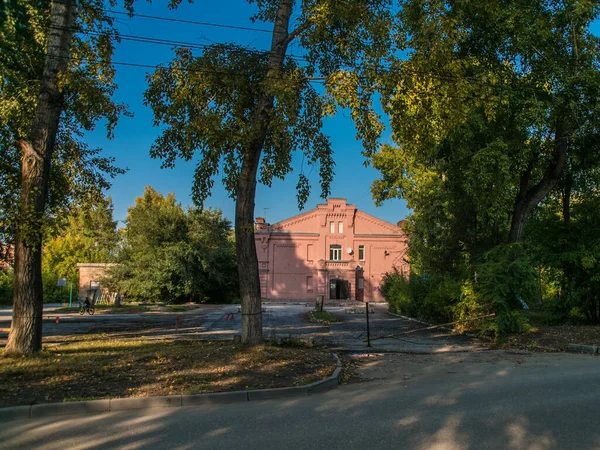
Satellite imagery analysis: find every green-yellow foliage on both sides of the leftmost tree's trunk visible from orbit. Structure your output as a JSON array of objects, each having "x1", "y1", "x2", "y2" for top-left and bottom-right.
[{"x1": 0, "y1": 0, "x2": 126, "y2": 246}]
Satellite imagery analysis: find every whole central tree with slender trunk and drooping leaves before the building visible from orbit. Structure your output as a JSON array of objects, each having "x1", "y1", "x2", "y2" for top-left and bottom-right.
[{"x1": 145, "y1": 0, "x2": 393, "y2": 344}]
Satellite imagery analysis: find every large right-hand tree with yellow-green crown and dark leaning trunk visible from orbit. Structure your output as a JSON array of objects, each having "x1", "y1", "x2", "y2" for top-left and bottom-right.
[{"x1": 375, "y1": 0, "x2": 600, "y2": 248}]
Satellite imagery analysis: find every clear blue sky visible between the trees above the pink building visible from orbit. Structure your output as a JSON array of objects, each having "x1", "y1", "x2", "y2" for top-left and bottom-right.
[{"x1": 87, "y1": 0, "x2": 408, "y2": 223}]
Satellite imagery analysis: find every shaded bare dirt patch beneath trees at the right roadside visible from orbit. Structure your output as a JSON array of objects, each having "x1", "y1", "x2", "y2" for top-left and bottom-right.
[{"x1": 503, "y1": 325, "x2": 600, "y2": 351}]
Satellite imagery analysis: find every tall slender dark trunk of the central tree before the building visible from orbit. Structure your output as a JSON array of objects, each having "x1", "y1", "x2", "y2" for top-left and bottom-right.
[{"x1": 235, "y1": 0, "x2": 294, "y2": 344}]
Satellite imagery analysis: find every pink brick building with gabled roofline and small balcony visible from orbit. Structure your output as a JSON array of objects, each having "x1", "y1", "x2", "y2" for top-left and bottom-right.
[{"x1": 255, "y1": 198, "x2": 409, "y2": 301}]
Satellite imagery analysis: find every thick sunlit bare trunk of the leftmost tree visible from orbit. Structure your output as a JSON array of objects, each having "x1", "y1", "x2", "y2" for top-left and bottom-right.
[{"x1": 5, "y1": 0, "x2": 75, "y2": 355}]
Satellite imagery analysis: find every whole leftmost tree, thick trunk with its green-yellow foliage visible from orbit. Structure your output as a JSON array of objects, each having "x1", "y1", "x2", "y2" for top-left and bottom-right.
[{"x1": 0, "y1": 0, "x2": 124, "y2": 354}]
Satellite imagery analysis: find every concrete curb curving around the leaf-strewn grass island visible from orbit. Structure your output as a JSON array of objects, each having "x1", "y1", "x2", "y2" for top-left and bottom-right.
[{"x1": 0, "y1": 353, "x2": 342, "y2": 422}]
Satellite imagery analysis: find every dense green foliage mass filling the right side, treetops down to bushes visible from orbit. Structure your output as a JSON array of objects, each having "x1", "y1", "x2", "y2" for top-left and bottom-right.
[{"x1": 372, "y1": 0, "x2": 600, "y2": 334}]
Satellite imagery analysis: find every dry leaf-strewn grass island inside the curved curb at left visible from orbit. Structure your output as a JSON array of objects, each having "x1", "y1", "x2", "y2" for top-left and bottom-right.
[{"x1": 0, "y1": 335, "x2": 335, "y2": 407}]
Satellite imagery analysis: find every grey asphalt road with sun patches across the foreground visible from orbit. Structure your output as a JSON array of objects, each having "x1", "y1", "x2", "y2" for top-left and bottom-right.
[{"x1": 0, "y1": 351, "x2": 600, "y2": 450}]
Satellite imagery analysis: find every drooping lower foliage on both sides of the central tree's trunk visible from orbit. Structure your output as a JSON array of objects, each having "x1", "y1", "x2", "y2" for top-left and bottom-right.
[{"x1": 144, "y1": 44, "x2": 334, "y2": 206}]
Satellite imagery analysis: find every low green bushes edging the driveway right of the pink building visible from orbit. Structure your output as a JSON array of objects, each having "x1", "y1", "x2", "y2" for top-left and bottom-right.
[{"x1": 381, "y1": 245, "x2": 536, "y2": 342}]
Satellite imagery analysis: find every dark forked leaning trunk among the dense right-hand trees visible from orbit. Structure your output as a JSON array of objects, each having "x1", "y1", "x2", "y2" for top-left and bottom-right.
[{"x1": 508, "y1": 120, "x2": 569, "y2": 243}]
